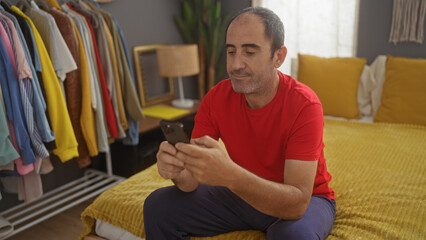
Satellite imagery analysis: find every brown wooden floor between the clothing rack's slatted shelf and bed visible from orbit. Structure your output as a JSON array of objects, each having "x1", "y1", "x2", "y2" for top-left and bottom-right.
[{"x1": 7, "y1": 199, "x2": 94, "y2": 240}]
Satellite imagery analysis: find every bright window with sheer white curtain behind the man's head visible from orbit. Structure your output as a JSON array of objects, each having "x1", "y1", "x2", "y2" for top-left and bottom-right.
[{"x1": 253, "y1": 0, "x2": 359, "y2": 74}]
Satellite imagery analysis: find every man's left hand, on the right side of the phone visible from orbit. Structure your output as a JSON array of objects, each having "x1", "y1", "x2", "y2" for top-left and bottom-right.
[{"x1": 175, "y1": 136, "x2": 239, "y2": 186}]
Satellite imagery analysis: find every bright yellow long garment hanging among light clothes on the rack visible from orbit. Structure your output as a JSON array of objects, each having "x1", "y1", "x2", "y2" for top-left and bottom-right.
[{"x1": 11, "y1": 6, "x2": 78, "y2": 162}]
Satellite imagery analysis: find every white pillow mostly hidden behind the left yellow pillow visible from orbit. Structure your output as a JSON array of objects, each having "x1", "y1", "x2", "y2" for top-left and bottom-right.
[{"x1": 291, "y1": 58, "x2": 372, "y2": 117}]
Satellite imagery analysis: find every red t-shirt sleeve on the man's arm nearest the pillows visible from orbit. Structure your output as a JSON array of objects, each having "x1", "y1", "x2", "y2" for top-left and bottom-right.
[{"x1": 285, "y1": 103, "x2": 324, "y2": 161}]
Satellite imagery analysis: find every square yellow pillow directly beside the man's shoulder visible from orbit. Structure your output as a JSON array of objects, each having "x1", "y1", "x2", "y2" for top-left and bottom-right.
[{"x1": 298, "y1": 54, "x2": 366, "y2": 118}]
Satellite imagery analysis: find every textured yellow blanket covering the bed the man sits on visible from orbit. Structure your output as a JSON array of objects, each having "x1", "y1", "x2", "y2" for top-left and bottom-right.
[{"x1": 81, "y1": 119, "x2": 426, "y2": 240}]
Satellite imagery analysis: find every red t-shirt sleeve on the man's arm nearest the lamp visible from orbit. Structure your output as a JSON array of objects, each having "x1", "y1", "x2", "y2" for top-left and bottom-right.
[{"x1": 191, "y1": 89, "x2": 219, "y2": 140}]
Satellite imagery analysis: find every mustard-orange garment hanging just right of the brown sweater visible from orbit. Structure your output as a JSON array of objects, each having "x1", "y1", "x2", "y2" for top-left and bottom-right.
[{"x1": 73, "y1": 22, "x2": 98, "y2": 157}]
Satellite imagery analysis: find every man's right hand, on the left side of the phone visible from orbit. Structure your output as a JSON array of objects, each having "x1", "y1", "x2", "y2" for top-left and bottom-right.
[{"x1": 157, "y1": 141, "x2": 184, "y2": 179}]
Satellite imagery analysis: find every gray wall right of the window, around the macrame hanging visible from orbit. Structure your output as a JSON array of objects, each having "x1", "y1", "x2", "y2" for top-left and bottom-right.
[{"x1": 357, "y1": 0, "x2": 426, "y2": 63}]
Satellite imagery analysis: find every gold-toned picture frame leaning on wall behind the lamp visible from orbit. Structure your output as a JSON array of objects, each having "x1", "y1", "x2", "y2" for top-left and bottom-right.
[{"x1": 133, "y1": 43, "x2": 176, "y2": 108}]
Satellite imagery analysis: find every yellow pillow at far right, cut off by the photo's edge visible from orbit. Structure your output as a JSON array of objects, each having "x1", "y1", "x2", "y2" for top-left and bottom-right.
[{"x1": 374, "y1": 55, "x2": 426, "y2": 125}]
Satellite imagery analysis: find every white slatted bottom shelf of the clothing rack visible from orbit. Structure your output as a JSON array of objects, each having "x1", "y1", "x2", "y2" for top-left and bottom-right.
[{"x1": 0, "y1": 151, "x2": 126, "y2": 239}]
